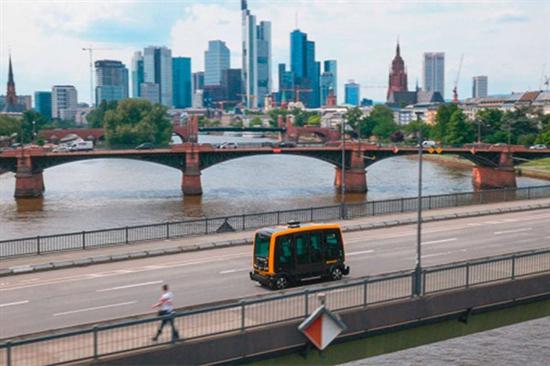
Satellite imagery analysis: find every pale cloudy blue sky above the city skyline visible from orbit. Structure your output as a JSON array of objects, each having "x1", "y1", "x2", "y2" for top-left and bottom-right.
[{"x1": 0, "y1": 0, "x2": 550, "y2": 106}]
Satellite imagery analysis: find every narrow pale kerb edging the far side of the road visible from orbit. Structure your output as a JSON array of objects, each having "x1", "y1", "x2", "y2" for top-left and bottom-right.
[{"x1": 0, "y1": 203, "x2": 550, "y2": 277}]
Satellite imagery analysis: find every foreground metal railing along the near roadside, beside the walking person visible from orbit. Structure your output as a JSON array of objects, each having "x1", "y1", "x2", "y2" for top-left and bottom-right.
[{"x1": 0, "y1": 248, "x2": 550, "y2": 366}]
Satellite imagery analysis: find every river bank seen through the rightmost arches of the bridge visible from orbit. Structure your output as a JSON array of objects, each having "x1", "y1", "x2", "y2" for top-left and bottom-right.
[{"x1": 418, "y1": 154, "x2": 550, "y2": 180}]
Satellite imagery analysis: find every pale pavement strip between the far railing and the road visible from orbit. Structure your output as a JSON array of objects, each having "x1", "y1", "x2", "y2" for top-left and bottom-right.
[{"x1": 4, "y1": 198, "x2": 550, "y2": 276}]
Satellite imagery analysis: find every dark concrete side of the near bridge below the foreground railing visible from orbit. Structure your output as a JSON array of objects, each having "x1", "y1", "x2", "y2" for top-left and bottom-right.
[{"x1": 98, "y1": 274, "x2": 550, "y2": 365}]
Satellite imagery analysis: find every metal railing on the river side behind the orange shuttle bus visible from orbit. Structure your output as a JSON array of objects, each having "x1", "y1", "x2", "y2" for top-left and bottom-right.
[{"x1": 0, "y1": 185, "x2": 550, "y2": 258}]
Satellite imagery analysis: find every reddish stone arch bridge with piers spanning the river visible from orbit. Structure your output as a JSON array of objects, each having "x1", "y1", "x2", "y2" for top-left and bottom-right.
[{"x1": 0, "y1": 142, "x2": 550, "y2": 197}]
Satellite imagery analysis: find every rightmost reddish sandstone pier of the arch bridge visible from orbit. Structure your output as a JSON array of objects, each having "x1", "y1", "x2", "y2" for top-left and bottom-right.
[{"x1": 472, "y1": 151, "x2": 517, "y2": 189}]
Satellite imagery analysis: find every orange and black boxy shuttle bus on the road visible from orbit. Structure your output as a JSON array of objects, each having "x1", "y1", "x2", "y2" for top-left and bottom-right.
[{"x1": 250, "y1": 221, "x2": 349, "y2": 290}]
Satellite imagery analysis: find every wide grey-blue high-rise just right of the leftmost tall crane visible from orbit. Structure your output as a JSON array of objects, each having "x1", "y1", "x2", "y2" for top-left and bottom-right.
[{"x1": 95, "y1": 60, "x2": 128, "y2": 106}]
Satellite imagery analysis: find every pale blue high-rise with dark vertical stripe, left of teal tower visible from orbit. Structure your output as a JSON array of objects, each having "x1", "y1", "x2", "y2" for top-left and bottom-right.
[{"x1": 140, "y1": 46, "x2": 173, "y2": 108}]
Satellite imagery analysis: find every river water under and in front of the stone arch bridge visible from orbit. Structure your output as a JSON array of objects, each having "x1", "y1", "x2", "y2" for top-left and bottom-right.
[{"x1": 0, "y1": 136, "x2": 547, "y2": 240}]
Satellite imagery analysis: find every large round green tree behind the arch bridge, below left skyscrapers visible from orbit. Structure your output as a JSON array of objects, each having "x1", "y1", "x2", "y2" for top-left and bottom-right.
[{"x1": 104, "y1": 99, "x2": 172, "y2": 145}]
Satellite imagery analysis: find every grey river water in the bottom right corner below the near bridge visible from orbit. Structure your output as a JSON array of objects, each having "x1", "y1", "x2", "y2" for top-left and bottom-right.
[{"x1": 342, "y1": 317, "x2": 550, "y2": 366}]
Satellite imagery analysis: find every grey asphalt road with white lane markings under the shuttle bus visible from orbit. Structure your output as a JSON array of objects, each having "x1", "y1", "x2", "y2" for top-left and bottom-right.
[{"x1": 0, "y1": 210, "x2": 550, "y2": 339}]
